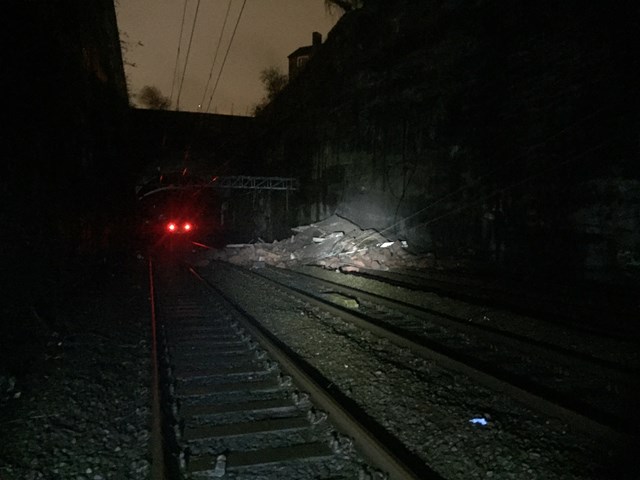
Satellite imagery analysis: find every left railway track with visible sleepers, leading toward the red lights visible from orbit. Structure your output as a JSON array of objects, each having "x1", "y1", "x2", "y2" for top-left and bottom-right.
[{"x1": 150, "y1": 265, "x2": 441, "y2": 480}]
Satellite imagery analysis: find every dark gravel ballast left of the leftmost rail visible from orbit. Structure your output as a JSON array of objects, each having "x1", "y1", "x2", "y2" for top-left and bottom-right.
[{"x1": 0, "y1": 265, "x2": 150, "y2": 480}]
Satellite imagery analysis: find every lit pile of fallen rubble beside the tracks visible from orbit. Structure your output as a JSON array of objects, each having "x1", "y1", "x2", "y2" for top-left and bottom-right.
[{"x1": 198, "y1": 215, "x2": 431, "y2": 272}]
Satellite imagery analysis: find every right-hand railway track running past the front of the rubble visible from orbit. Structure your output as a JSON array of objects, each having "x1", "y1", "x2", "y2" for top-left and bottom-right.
[{"x1": 208, "y1": 258, "x2": 640, "y2": 443}]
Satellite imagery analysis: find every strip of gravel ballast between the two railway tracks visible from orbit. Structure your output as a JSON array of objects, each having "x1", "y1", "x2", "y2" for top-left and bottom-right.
[{"x1": 204, "y1": 264, "x2": 635, "y2": 480}]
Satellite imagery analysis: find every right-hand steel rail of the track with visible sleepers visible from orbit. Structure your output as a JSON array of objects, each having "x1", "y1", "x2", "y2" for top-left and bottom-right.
[{"x1": 189, "y1": 268, "x2": 443, "y2": 480}]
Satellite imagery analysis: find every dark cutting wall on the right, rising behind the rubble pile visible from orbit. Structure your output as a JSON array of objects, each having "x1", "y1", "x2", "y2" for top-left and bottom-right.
[{"x1": 260, "y1": 0, "x2": 640, "y2": 284}]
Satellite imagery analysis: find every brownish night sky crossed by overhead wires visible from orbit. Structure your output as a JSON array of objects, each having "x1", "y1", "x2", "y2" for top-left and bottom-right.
[{"x1": 116, "y1": 0, "x2": 339, "y2": 115}]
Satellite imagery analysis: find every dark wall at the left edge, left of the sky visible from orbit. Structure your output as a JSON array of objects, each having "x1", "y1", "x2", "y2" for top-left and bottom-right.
[{"x1": 0, "y1": 0, "x2": 133, "y2": 310}]
